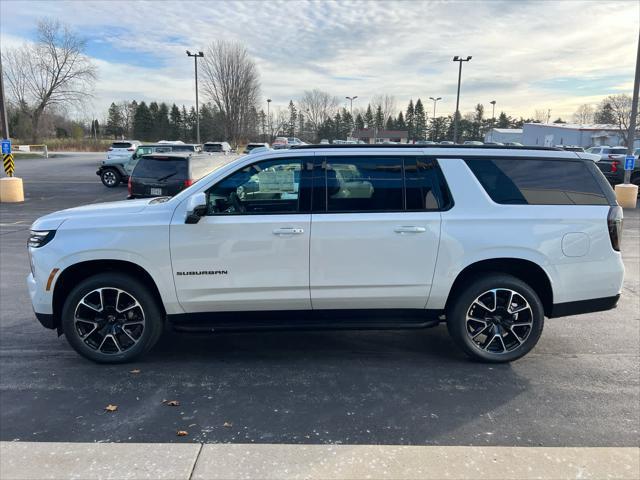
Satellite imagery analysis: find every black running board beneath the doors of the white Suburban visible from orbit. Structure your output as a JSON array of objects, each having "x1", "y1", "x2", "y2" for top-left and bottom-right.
[{"x1": 167, "y1": 309, "x2": 441, "y2": 332}]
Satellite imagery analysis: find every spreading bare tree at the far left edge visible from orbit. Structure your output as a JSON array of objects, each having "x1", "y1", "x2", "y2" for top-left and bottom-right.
[{"x1": 3, "y1": 19, "x2": 96, "y2": 143}]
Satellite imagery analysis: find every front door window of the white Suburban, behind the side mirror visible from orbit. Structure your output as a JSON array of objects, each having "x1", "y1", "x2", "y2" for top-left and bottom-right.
[{"x1": 207, "y1": 159, "x2": 301, "y2": 215}]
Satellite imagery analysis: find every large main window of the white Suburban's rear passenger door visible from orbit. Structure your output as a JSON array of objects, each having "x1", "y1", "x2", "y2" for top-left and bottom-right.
[{"x1": 328, "y1": 157, "x2": 404, "y2": 212}]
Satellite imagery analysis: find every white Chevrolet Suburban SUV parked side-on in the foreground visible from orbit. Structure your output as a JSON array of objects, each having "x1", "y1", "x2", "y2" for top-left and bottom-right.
[{"x1": 27, "y1": 145, "x2": 624, "y2": 363}]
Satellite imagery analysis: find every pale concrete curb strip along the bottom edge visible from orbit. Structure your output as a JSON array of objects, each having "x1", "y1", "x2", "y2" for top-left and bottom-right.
[{"x1": 0, "y1": 442, "x2": 640, "y2": 480}]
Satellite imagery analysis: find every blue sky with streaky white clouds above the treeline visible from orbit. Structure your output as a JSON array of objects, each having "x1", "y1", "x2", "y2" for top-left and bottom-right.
[{"x1": 0, "y1": 0, "x2": 640, "y2": 120}]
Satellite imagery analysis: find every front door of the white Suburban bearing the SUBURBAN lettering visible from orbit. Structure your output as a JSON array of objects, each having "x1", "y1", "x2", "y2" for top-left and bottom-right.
[{"x1": 171, "y1": 157, "x2": 311, "y2": 313}]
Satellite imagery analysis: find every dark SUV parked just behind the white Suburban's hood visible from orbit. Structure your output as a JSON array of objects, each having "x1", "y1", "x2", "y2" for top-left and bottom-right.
[{"x1": 129, "y1": 152, "x2": 216, "y2": 198}]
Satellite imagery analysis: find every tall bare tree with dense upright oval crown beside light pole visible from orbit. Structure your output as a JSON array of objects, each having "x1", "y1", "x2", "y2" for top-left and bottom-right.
[{"x1": 202, "y1": 40, "x2": 260, "y2": 144}]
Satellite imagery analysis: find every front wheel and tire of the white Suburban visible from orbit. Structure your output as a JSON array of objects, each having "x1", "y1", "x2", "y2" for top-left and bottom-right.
[{"x1": 61, "y1": 273, "x2": 164, "y2": 363}]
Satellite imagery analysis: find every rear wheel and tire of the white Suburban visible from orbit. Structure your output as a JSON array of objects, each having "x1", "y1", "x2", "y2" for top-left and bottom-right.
[{"x1": 447, "y1": 273, "x2": 544, "y2": 363}]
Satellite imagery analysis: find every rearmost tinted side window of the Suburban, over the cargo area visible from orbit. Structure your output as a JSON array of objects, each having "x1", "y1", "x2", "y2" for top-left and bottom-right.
[{"x1": 467, "y1": 158, "x2": 609, "y2": 205}]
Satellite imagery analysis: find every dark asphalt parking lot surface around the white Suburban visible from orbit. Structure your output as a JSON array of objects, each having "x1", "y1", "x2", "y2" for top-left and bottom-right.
[{"x1": 0, "y1": 154, "x2": 640, "y2": 446}]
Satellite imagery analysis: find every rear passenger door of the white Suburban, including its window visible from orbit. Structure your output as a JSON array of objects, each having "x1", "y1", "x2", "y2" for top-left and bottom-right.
[{"x1": 310, "y1": 154, "x2": 444, "y2": 309}]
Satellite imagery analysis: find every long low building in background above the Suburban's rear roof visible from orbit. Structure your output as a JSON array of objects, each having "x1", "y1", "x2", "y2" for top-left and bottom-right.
[{"x1": 522, "y1": 123, "x2": 624, "y2": 147}]
